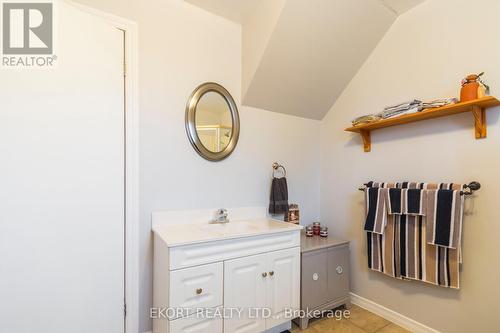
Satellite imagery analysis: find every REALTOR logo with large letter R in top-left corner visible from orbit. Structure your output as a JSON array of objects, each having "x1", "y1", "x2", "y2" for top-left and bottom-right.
[{"x1": 1, "y1": 0, "x2": 57, "y2": 67}]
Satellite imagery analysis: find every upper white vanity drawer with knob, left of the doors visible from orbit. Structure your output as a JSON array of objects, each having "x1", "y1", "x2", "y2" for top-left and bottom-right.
[{"x1": 169, "y1": 262, "x2": 223, "y2": 314}]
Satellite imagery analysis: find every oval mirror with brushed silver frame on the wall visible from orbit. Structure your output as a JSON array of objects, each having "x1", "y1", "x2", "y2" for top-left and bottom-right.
[{"x1": 186, "y1": 82, "x2": 240, "y2": 161}]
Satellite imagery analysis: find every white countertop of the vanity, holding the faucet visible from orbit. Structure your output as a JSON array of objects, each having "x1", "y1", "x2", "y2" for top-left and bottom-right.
[{"x1": 153, "y1": 219, "x2": 303, "y2": 247}]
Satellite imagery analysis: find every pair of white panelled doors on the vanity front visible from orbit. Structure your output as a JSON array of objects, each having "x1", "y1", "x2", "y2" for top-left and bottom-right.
[{"x1": 224, "y1": 247, "x2": 300, "y2": 333}]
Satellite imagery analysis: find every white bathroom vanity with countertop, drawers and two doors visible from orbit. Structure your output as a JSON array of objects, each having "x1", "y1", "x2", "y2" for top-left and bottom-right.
[{"x1": 152, "y1": 220, "x2": 300, "y2": 333}]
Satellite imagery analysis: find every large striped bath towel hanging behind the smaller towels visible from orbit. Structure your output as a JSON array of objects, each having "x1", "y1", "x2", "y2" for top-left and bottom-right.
[{"x1": 367, "y1": 182, "x2": 462, "y2": 289}]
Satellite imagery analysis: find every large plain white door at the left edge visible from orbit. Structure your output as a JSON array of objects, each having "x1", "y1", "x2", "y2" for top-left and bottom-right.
[{"x1": 0, "y1": 1, "x2": 124, "y2": 333}]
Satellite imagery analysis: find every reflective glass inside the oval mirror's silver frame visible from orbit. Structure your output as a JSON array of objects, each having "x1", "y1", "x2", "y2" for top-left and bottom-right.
[{"x1": 195, "y1": 91, "x2": 233, "y2": 153}]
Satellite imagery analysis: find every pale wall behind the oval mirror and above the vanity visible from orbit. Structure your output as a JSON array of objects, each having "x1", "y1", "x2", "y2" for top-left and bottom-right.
[{"x1": 72, "y1": 0, "x2": 320, "y2": 332}]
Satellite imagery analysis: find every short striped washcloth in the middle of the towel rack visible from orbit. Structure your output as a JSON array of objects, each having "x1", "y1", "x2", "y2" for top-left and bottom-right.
[{"x1": 387, "y1": 188, "x2": 427, "y2": 215}]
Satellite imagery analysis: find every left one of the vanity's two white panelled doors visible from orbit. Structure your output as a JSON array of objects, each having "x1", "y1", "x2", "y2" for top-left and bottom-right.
[{"x1": 224, "y1": 254, "x2": 267, "y2": 333}]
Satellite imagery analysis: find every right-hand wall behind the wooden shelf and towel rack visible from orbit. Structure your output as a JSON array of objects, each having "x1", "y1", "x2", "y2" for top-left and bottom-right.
[{"x1": 321, "y1": 0, "x2": 500, "y2": 333}]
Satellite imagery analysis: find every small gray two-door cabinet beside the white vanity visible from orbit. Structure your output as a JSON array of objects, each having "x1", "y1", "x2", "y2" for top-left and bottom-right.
[{"x1": 297, "y1": 235, "x2": 350, "y2": 329}]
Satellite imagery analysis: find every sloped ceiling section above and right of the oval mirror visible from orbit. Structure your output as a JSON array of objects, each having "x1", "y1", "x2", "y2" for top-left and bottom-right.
[{"x1": 186, "y1": 0, "x2": 424, "y2": 119}]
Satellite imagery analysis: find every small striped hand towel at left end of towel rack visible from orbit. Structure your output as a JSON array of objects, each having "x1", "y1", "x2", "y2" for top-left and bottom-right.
[{"x1": 365, "y1": 187, "x2": 388, "y2": 234}]
